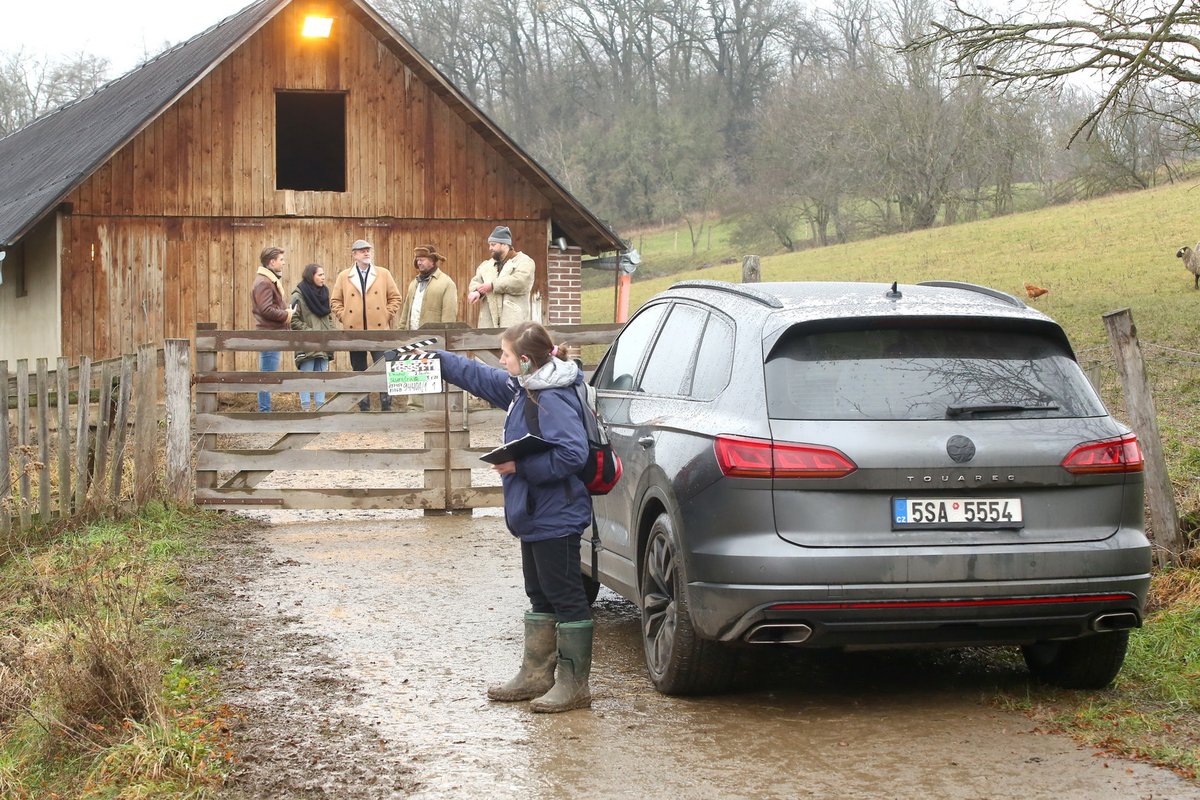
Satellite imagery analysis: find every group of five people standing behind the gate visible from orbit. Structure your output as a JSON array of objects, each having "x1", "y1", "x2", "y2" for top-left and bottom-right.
[{"x1": 251, "y1": 225, "x2": 536, "y2": 411}]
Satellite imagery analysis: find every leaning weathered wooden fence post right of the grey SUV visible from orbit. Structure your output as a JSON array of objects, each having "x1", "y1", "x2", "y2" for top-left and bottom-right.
[{"x1": 1104, "y1": 308, "x2": 1184, "y2": 565}]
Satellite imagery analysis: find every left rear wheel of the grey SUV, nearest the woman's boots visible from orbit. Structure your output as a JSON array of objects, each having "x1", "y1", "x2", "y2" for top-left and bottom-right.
[{"x1": 638, "y1": 513, "x2": 737, "y2": 694}]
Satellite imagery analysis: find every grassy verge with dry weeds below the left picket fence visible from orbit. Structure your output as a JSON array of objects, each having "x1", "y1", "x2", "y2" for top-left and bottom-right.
[{"x1": 0, "y1": 504, "x2": 233, "y2": 800}]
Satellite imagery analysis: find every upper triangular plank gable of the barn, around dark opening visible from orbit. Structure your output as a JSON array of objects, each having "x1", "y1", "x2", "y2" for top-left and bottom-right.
[{"x1": 68, "y1": 4, "x2": 550, "y2": 219}]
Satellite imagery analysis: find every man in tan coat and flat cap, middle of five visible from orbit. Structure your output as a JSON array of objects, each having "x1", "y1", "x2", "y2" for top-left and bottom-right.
[{"x1": 329, "y1": 239, "x2": 402, "y2": 411}]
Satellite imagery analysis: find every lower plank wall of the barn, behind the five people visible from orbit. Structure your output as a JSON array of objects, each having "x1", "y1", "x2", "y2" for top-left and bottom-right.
[{"x1": 62, "y1": 215, "x2": 546, "y2": 369}]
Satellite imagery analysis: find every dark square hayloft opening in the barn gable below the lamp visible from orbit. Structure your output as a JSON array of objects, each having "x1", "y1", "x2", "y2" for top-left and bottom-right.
[{"x1": 275, "y1": 91, "x2": 346, "y2": 192}]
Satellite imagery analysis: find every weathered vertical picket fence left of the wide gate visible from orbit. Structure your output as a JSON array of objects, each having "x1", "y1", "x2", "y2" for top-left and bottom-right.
[{"x1": 0, "y1": 341, "x2": 191, "y2": 535}]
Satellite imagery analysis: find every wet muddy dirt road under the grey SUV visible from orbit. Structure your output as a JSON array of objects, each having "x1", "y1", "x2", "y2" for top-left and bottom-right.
[{"x1": 196, "y1": 512, "x2": 1200, "y2": 800}]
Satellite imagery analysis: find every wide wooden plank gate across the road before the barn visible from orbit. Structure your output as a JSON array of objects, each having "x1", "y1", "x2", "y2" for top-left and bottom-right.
[{"x1": 194, "y1": 324, "x2": 620, "y2": 513}]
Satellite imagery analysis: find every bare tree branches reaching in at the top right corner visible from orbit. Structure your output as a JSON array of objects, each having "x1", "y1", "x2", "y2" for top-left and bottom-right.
[{"x1": 906, "y1": 0, "x2": 1200, "y2": 142}]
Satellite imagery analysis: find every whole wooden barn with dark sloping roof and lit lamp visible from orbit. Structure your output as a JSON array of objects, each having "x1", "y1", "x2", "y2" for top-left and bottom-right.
[{"x1": 0, "y1": 0, "x2": 620, "y2": 365}]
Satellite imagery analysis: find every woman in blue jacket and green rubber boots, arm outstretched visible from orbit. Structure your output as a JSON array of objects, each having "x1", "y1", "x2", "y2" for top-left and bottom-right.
[{"x1": 427, "y1": 323, "x2": 592, "y2": 711}]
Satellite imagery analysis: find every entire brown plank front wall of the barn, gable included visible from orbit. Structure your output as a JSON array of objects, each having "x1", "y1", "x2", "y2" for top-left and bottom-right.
[{"x1": 61, "y1": 2, "x2": 561, "y2": 361}]
